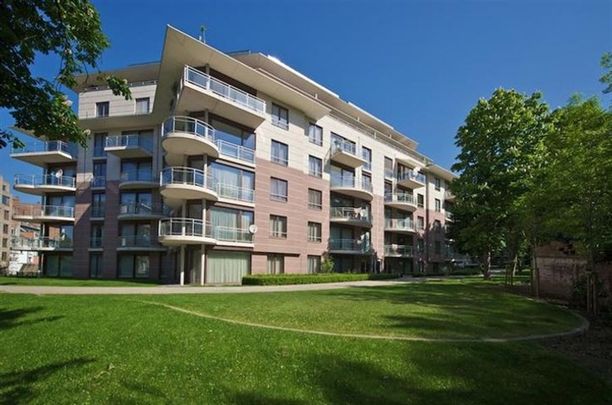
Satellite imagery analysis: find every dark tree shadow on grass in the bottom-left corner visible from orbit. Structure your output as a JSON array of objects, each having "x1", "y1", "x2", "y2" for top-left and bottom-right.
[{"x1": 0, "y1": 358, "x2": 94, "y2": 404}]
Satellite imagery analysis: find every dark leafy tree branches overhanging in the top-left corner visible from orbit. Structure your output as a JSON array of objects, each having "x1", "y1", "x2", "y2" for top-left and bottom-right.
[{"x1": 0, "y1": 0, "x2": 131, "y2": 148}]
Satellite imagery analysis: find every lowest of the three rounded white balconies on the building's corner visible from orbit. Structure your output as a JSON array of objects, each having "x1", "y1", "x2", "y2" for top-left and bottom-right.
[{"x1": 159, "y1": 218, "x2": 217, "y2": 246}]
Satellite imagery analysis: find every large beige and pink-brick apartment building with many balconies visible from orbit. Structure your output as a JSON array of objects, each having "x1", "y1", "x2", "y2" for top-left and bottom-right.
[{"x1": 12, "y1": 27, "x2": 453, "y2": 284}]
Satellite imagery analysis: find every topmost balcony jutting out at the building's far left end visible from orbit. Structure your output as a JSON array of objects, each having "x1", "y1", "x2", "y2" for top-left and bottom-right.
[{"x1": 11, "y1": 141, "x2": 77, "y2": 167}]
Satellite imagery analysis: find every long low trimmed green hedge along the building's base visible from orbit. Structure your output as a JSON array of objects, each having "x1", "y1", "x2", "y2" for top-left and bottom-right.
[{"x1": 242, "y1": 273, "x2": 399, "y2": 285}]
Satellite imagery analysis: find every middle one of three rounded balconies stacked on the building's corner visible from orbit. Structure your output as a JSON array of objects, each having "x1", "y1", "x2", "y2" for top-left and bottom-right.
[{"x1": 160, "y1": 167, "x2": 219, "y2": 204}]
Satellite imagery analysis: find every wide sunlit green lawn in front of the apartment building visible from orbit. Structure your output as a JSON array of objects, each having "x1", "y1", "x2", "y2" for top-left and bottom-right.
[{"x1": 0, "y1": 281, "x2": 612, "y2": 404}]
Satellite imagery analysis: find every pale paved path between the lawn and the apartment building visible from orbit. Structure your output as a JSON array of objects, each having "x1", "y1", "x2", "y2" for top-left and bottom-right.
[{"x1": 0, "y1": 278, "x2": 418, "y2": 295}]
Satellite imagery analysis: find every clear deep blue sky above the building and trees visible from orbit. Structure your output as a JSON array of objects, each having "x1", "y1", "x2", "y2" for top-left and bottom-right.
[{"x1": 0, "y1": 0, "x2": 612, "y2": 201}]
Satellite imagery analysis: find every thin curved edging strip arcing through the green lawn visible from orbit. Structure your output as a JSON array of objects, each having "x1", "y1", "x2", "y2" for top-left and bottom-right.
[{"x1": 136, "y1": 301, "x2": 589, "y2": 343}]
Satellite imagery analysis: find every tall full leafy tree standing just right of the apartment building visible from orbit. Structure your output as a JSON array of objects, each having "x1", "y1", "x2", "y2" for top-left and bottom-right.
[{"x1": 451, "y1": 89, "x2": 552, "y2": 278}]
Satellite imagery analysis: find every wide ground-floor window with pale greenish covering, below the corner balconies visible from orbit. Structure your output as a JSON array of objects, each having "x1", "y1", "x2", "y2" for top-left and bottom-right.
[{"x1": 206, "y1": 251, "x2": 251, "y2": 284}]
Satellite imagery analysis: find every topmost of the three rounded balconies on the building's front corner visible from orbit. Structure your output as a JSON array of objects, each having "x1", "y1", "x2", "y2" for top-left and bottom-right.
[{"x1": 162, "y1": 116, "x2": 219, "y2": 158}]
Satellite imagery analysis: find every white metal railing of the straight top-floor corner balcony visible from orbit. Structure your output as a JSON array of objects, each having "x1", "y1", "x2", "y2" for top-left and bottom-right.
[{"x1": 184, "y1": 66, "x2": 266, "y2": 114}]
